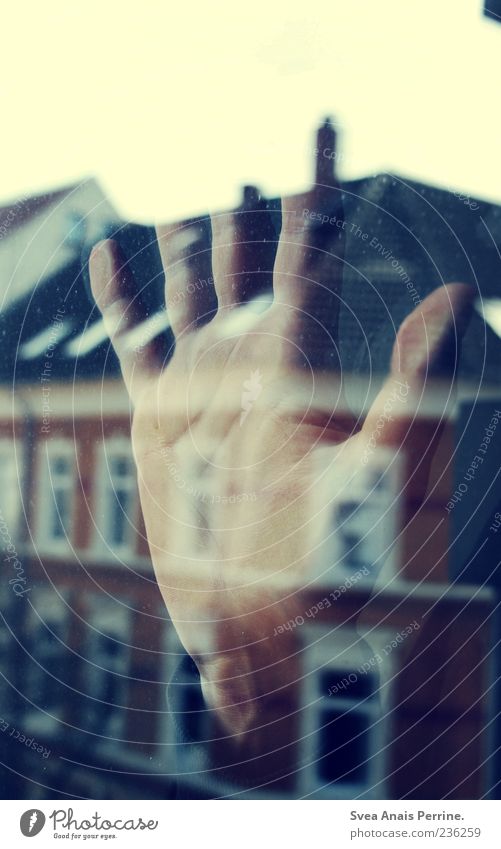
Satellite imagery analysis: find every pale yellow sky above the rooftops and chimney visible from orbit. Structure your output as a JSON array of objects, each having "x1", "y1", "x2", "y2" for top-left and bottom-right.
[{"x1": 0, "y1": 0, "x2": 501, "y2": 219}]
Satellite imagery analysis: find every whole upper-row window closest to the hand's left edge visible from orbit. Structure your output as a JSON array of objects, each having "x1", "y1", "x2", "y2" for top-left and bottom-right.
[{"x1": 96, "y1": 437, "x2": 138, "y2": 555}]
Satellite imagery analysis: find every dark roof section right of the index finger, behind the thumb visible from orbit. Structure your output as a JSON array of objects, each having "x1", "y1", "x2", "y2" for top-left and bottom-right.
[{"x1": 340, "y1": 174, "x2": 501, "y2": 383}]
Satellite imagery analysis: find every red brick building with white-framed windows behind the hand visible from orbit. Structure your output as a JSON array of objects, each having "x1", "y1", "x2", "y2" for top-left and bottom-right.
[{"x1": 0, "y1": 175, "x2": 501, "y2": 798}]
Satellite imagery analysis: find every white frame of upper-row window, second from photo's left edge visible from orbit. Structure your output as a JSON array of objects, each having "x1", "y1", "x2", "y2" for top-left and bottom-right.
[{"x1": 35, "y1": 438, "x2": 77, "y2": 554}]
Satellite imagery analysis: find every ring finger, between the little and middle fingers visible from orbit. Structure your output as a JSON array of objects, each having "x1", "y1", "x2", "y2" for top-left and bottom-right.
[{"x1": 157, "y1": 218, "x2": 217, "y2": 337}]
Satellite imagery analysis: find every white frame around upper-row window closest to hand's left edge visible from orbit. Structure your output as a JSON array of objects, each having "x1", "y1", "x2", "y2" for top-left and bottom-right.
[{"x1": 92, "y1": 436, "x2": 139, "y2": 561}]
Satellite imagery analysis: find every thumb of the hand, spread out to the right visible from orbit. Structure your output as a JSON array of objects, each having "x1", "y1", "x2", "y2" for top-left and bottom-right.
[{"x1": 362, "y1": 283, "x2": 474, "y2": 501}]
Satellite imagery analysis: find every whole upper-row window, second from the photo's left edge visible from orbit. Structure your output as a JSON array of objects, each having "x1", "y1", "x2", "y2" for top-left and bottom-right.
[{"x1": 39, "y1": 440, "x2": 75, "y2": 551}]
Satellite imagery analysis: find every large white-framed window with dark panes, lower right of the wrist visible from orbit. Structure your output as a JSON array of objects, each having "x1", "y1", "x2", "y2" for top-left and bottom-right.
[{"x1": 300, "y1": 626, "x2": 387, "y2": 798}]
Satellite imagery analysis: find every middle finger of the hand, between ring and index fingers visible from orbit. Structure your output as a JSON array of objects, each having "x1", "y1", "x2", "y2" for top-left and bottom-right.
[{"x1": 212, "y1": 186, "x2": 277, "y2": 309}]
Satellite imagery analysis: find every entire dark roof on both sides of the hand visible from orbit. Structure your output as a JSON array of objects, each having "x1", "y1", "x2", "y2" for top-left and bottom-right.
[{"x1": 0, "y1": 174, "x2": 501, "y2": 382}]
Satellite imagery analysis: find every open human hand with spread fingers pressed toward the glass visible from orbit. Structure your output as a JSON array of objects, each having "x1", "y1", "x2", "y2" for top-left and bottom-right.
[{"x1": 91, "y1": 156, "x2": 471, "y2": 739}]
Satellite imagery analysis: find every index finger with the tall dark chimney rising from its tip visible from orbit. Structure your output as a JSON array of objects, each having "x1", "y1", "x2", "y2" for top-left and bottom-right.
[{"x1": 273, "y1": 122, "x2": 346, "y2": 372}]
